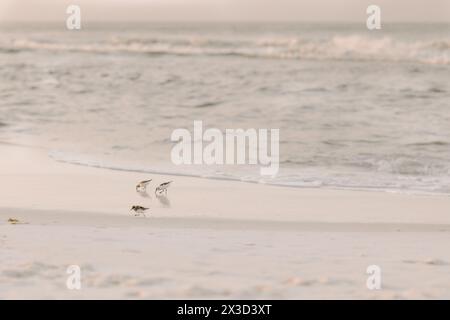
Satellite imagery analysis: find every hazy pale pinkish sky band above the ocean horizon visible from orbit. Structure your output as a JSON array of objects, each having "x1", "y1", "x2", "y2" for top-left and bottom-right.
[{"x1": 0, "y1": 0, "x2": 450, "y2": 22}]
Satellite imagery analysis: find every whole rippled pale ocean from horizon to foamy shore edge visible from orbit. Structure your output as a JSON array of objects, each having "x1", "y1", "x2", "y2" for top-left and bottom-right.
[{"x1": 0, "y1": 23, "x2": 450, "y2": 194}]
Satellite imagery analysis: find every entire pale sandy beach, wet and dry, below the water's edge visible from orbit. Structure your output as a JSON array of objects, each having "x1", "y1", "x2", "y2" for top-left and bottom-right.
[{"x1": 0, "y1": 145, "x2": 450, "y2": 299}]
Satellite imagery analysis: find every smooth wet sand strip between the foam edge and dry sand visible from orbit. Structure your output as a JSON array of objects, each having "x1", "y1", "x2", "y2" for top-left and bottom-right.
[{"x1": 0, "y1": 145, "x2": 450, "y2": 224}]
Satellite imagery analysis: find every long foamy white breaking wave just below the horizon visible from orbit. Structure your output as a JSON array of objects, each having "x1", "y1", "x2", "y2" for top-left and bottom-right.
[{"x1": 0, "y1": 35, "x2": 450, "y2": 64}]
